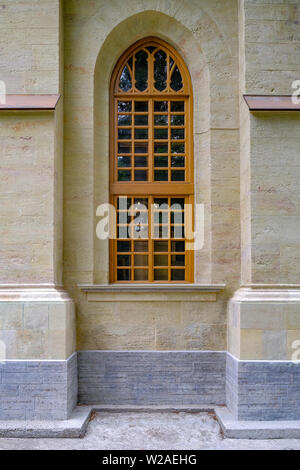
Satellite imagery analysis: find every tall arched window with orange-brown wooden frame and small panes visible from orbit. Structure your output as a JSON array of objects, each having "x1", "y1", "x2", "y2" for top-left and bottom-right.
[{"x1": 110, "y1": 38, "x2": 194, "y2": 283}]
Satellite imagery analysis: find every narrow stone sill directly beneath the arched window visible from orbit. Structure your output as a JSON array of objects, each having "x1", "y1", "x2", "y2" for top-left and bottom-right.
[{"x1": 78, "y1": 284, "x2": 226, "y2": 302}]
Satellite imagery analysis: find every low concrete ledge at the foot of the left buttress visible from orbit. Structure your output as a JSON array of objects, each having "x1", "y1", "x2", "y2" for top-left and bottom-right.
[{"x1": 0, "y1": 406, "x2": 92, "y2": 438}]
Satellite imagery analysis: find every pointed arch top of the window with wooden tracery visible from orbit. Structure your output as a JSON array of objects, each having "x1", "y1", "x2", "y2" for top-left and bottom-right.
[{"x1": 111, "y1": 37, "x2": 192, "y2": 96}]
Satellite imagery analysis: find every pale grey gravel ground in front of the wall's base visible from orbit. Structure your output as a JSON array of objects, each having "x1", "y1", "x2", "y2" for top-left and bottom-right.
[{"x1": 0, "y1": 412, "x2": 300, "y2": 450}]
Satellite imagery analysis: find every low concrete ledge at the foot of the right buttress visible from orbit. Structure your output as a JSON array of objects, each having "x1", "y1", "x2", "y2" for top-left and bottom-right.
[{"x1": 215, "y1": 407, "x2": 300, "y2": 439}]
